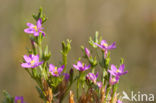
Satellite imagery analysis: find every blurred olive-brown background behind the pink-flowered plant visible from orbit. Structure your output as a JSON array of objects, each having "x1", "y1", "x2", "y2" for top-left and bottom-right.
[{"x1": 0, "y1": 0, "x2": 156, "y2": 103}]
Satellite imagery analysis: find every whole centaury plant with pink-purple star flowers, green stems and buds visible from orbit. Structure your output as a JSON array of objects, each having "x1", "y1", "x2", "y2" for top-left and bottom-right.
[{"x1": 3, "y1": 8, "x2": 127, "y2": 103}]
